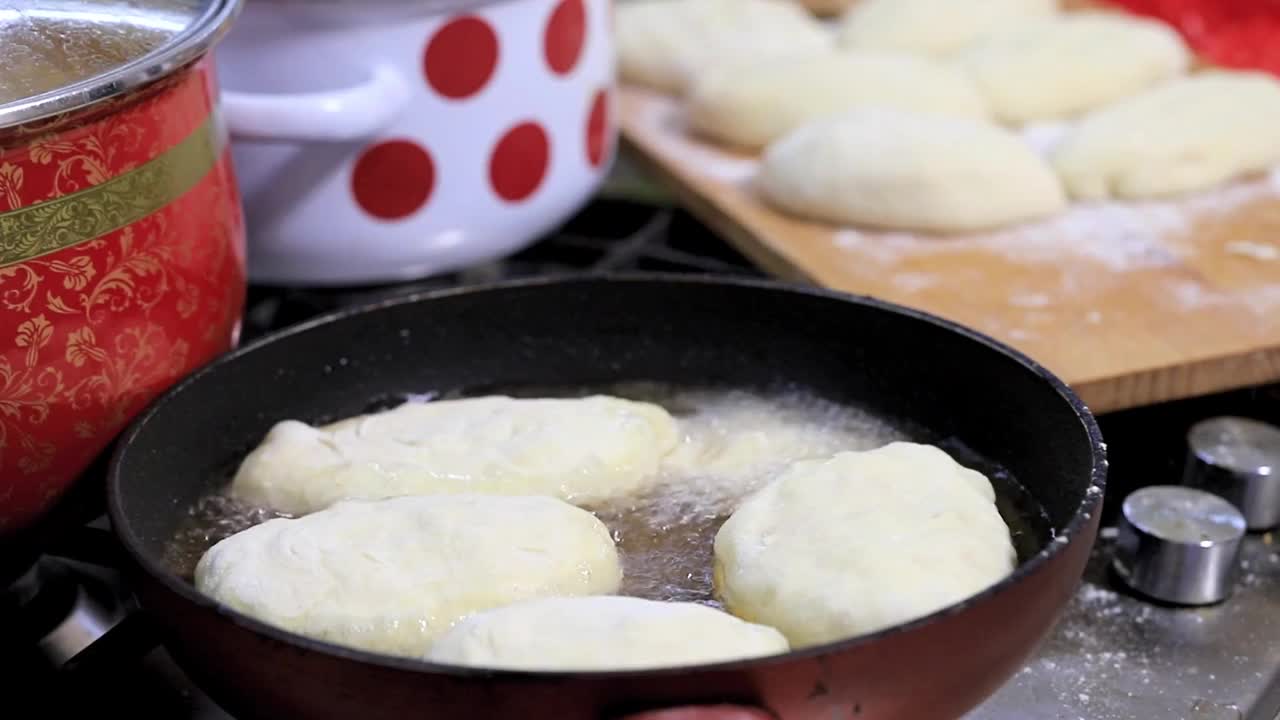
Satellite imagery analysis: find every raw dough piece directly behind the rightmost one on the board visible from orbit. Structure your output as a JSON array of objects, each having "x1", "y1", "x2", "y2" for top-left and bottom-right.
[{"x1": 960, "y1": 13, "x2": 1192, "y2": 124}]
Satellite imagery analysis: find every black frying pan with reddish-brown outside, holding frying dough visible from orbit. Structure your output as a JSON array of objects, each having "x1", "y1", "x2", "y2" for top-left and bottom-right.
[{"x1": 108, "y1": 277, "x2": 1106, "y2": 720}]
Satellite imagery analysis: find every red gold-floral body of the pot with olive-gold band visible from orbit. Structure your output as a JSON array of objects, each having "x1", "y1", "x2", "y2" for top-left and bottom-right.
[{"x1": 0, "y1": 60, "x2": 246, "y2": 534}]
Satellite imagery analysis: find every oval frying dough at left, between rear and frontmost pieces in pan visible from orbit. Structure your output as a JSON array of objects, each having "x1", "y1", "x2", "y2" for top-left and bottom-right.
[{"x1": 196, "y1": 495, "x2": 622, "y2": 657}]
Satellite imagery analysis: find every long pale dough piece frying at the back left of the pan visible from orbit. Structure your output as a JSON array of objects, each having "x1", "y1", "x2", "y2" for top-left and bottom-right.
[{"x1": 232, "y1": 396, "x2": 678, "y2": 515}]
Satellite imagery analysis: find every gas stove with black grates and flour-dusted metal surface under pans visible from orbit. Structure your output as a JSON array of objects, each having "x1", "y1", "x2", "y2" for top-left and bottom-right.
[{"x1": 0, "y1": 193, "x2": 1280, "y2": 720}]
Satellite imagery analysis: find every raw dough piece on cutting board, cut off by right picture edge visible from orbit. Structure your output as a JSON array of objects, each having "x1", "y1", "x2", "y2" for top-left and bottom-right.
[{"x1": 1052, "y1": 70, "x2": 1280, "y2": 200}]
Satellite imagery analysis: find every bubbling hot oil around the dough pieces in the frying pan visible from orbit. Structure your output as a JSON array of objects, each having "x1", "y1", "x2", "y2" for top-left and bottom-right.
[{"x1": 166, "y1": 383, "x2": 1051, "y2": 605}]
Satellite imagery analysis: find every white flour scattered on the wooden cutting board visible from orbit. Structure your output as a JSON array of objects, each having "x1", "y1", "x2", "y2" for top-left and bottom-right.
[{"x1": 635, "y1": 87, "x2": 1280, "y2": 316}]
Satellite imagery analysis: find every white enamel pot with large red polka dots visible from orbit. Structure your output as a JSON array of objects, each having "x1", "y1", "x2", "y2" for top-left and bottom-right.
[{"x1": 218, "y1": 0, "x2": 616, "y2": 286}]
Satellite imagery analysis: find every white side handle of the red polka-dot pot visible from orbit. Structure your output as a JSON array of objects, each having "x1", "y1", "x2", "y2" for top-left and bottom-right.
[{"x1": 221, "y1": 63, "x2": 410, "y2": 142}]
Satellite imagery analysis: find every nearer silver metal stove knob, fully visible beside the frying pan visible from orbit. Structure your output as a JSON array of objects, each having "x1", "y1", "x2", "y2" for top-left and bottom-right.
[{"x1": 1112, "y1": 486, "x2": 1245, "y2": 605}]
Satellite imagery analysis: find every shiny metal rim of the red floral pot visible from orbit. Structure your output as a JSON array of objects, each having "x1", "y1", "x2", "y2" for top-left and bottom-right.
[{"x1": 0, "y1": 0, "x2": 244, "y2": 128}]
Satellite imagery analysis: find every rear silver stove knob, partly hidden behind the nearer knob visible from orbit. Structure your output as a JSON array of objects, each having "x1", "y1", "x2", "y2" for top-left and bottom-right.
[{"x1": 1183, "y1": 416, "x2": 1280, "y2": 530}]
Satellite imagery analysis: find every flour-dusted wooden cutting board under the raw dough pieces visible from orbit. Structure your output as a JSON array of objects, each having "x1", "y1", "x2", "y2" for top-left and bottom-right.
[{"x1": 620, "y1": 87, "x2": 1280, "y2": 413}]
